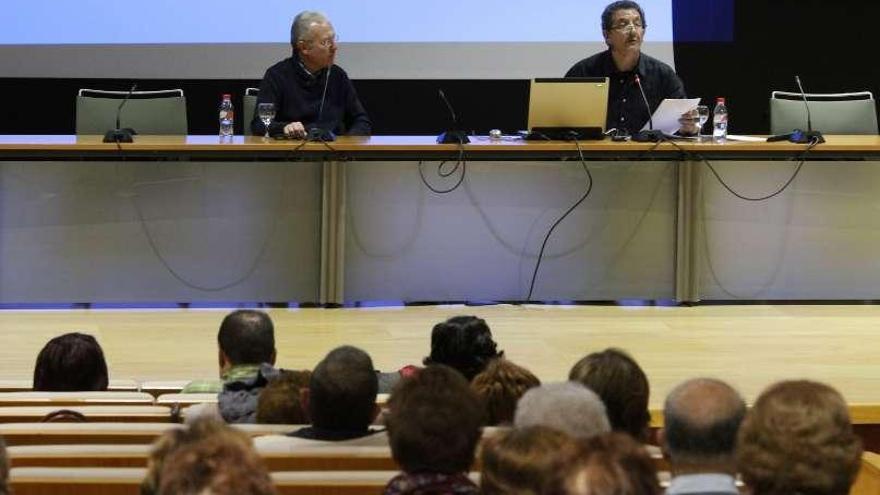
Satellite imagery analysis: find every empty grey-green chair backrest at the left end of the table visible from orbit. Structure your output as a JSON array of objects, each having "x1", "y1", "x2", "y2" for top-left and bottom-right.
[{"x1": 76, "y1": 89, "x2": 187, "y2": 135}]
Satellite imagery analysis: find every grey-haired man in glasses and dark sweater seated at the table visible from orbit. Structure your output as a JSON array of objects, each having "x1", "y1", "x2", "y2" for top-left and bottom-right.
[{"x1": 251, "y1": 11, "x2": 372, "y2": 138}]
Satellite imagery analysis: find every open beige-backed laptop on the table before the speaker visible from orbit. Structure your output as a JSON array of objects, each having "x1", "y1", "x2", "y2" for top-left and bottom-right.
[{"x1": 527, "y1": 77, "x2": 608, "y2": 140}]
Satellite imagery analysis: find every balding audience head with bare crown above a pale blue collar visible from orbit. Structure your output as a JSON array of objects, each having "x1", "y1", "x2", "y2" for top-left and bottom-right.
[{"x1": 661, "y1": 378, "x2": 746, "y2": 474}]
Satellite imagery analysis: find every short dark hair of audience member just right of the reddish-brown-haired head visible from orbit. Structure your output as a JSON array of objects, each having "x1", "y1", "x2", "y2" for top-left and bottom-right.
[{"x1": 309, "y1": 346, "x2": 379, "y2": 430}]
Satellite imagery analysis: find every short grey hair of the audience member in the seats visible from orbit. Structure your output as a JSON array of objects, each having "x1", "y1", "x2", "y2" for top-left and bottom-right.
[{"x1": 513, "y1": 382, "x2": 611, "y2": 440}]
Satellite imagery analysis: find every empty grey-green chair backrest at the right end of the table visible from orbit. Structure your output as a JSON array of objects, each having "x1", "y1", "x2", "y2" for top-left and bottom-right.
[{"x1": 770, "y1": 91, "x2": 877, "y2": 135}]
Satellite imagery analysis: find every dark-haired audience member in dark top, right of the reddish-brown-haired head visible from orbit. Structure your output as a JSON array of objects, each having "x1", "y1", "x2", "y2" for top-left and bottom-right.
[{"x1": 255, "y1": 346, "x2": 388, "y2": 450}]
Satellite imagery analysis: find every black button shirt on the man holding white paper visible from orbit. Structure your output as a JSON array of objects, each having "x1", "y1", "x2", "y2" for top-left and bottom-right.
[{"x1": 565, "y1": 50, "x2": 687, "y2": 134}]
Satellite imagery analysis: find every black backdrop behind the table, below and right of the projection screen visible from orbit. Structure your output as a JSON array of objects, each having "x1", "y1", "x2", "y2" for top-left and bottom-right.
[{"x1": 0, "y1": 0, "x2": 880, "y2": 134}]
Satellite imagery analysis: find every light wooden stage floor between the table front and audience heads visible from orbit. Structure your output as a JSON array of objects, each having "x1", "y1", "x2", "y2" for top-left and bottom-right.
[{"x1": 0, "y1": 305, "x2": 880, "y2": 408}]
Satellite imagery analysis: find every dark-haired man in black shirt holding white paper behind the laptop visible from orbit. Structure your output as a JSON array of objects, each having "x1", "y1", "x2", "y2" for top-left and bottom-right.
[{"x1": 565, "y1": 1, "x2": 696, "y2": 134}]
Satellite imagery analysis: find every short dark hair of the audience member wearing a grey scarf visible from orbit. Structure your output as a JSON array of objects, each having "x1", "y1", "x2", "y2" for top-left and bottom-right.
[{"x1": 217, "y1": 309, "x2": 275, "y2": 364}]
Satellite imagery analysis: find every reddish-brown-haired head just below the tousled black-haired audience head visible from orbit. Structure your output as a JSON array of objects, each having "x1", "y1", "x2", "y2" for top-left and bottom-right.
[{"x1": 471, "y1": 358, "x2": 541, "y2": 426}]
